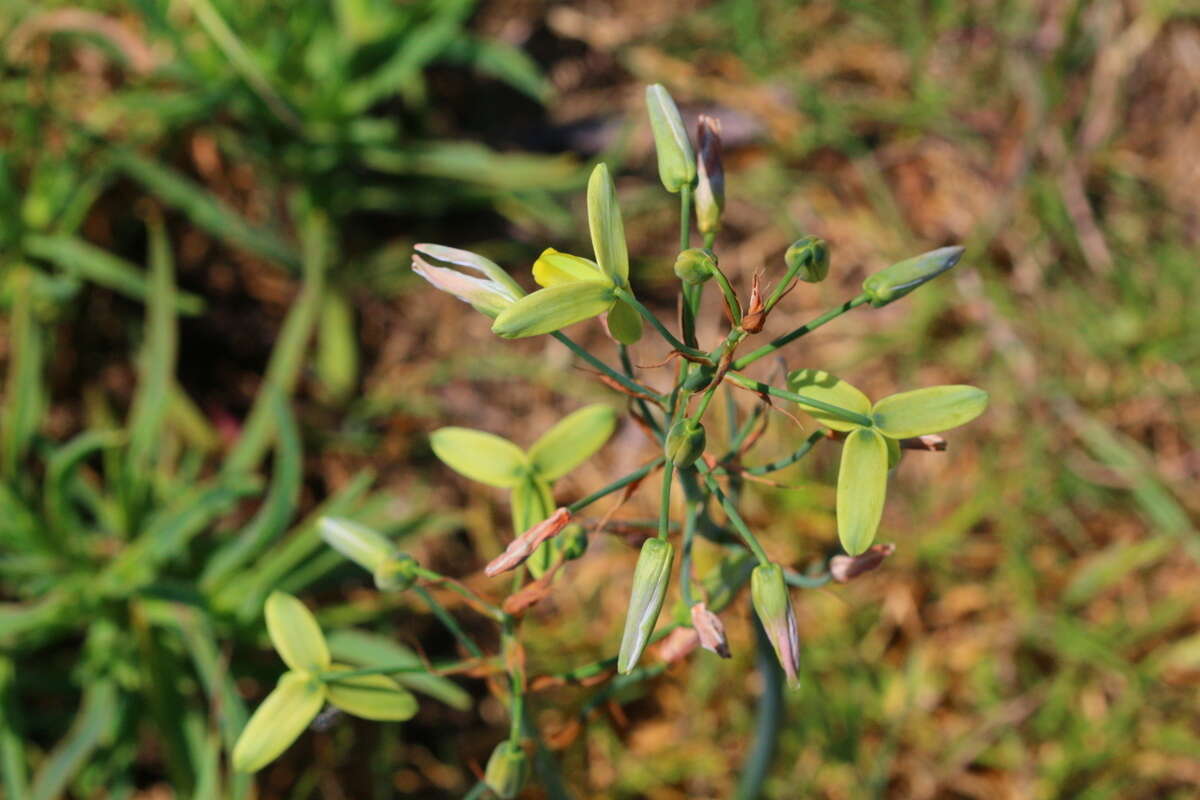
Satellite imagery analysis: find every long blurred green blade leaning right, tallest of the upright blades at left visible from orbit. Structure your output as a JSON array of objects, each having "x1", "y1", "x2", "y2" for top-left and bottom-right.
[{"x1": 222, "y1": 213, "x2": 330, "y2": 475}]
